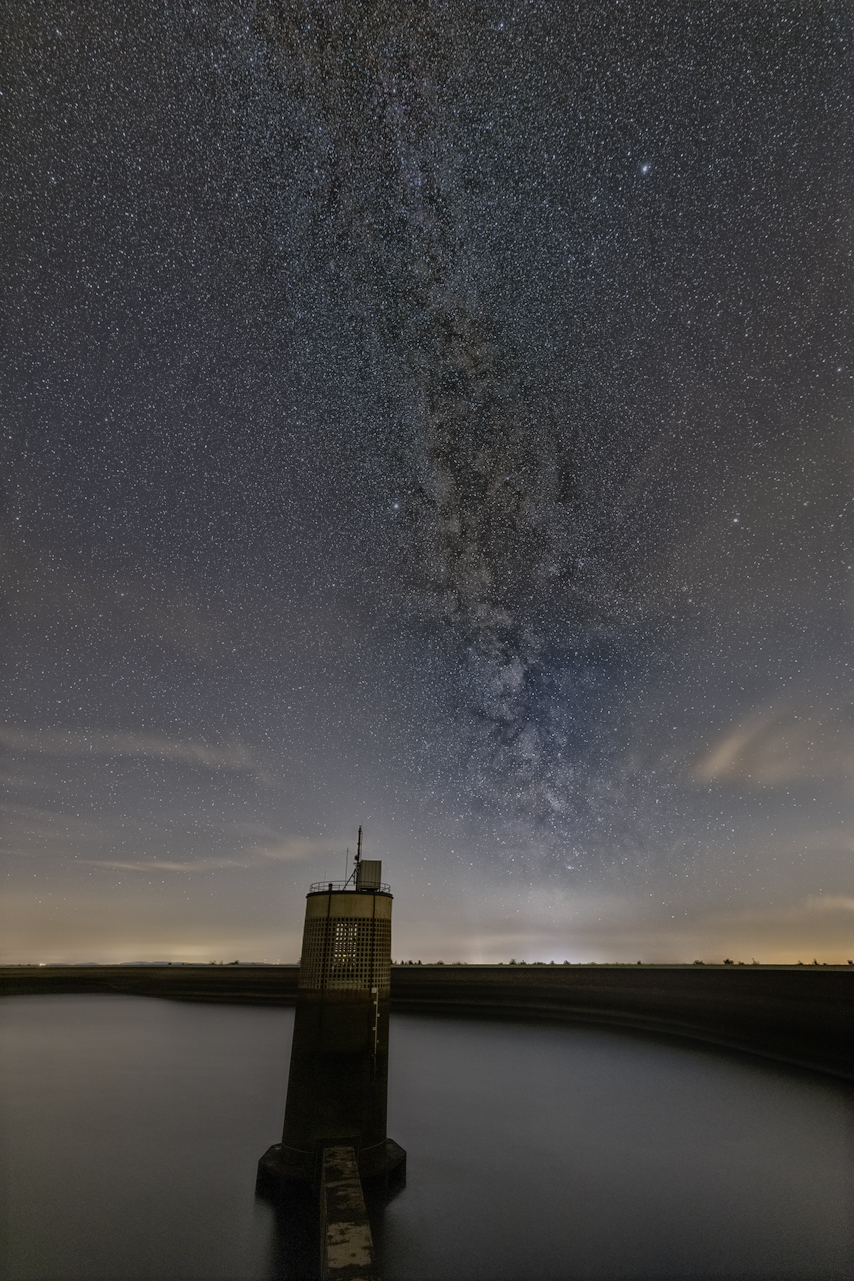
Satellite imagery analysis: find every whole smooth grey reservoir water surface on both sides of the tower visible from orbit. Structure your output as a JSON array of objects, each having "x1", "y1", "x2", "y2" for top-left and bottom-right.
[{"x1": 0, "y1": 995, "x2": 854, "y2": 1281}]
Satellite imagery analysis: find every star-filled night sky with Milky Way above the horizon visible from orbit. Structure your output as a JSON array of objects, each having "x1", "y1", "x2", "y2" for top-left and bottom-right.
[{"x1": 0, "y1": 0, "x2": 854, "y2": 961}]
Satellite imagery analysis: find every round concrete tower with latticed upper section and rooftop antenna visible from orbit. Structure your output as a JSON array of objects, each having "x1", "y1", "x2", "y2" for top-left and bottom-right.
[{"x1": 260, "y1": 829, "x2": 406, "y2": 1181}]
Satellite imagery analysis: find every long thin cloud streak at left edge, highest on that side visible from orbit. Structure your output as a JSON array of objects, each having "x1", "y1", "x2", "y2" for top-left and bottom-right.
[{"x1": 0, "y1": 725, "x2": 260, "y2": 772}]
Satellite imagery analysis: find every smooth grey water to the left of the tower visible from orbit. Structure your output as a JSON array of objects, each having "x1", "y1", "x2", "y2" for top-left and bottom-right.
[{"x1": 0, "y1": 995, "x2": 286, "y2": 1281}]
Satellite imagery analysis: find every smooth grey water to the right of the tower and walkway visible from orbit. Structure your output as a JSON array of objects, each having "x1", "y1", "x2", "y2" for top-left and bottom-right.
[{"x1": 378, "y1": 1016, "x2": 854, "y2": 1281}]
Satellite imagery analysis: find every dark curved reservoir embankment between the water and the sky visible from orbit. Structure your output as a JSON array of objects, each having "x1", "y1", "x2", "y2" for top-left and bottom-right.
[{"x1": 0, "y1": 965, "x2": 854, "y2": 1080}]
